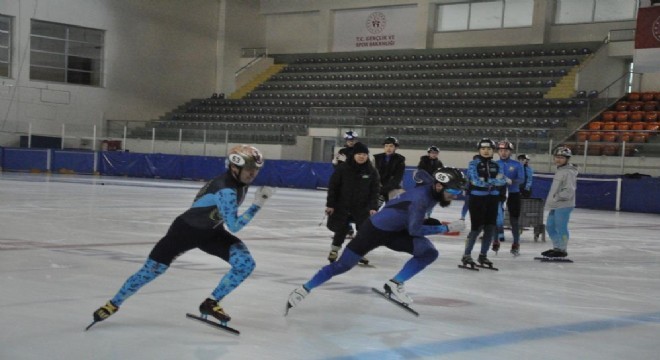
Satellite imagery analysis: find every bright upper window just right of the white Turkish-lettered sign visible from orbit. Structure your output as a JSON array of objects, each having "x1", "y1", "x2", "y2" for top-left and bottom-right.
[{"x1": 436, "y1": 0, "x2": 534, "y2": 31}]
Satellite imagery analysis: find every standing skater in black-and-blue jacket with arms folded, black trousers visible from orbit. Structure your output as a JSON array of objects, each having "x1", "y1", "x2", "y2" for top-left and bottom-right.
[{"x1": 461, "y1": 138, "x2": 511, "y2": 267}]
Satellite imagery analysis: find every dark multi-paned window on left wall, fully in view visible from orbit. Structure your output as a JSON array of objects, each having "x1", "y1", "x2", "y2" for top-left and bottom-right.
[{"x1": 30, "y1": 20, "x2": 104, "y2": 86}]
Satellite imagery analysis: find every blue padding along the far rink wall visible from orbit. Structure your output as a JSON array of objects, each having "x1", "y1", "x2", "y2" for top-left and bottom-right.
[{"x1": 0, "y1": 148, "x2": 660, "y2": 213}]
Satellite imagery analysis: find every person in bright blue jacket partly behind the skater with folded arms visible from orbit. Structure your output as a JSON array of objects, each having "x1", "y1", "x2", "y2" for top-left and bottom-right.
[{"x1": 493, "y1": 140, "x2": 525, "y2": 256}]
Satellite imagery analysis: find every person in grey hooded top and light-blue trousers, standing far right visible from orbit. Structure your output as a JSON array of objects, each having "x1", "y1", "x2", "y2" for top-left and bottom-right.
[{"x1": 541, "y1": 146, "x2": 578, "y2": 258}]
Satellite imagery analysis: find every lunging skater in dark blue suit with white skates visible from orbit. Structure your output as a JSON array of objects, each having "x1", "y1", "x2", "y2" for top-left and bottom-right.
[{"x1": 286, "y1": 167, "x2": 466, "y2": 313}]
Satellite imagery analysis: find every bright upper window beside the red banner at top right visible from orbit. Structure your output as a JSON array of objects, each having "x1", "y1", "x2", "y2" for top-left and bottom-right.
[{"x1": 555, "y1": 0, "x2": 637, "y2": 24}]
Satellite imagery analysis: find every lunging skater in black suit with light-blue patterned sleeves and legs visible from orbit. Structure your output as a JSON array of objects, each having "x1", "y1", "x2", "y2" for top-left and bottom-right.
[{"x1": 90, "y1": 145, "x2": 274, "y2": 326}]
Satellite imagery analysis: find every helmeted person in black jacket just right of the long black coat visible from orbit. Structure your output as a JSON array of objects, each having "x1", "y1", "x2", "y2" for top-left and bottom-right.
[{"x1": 374, "y1": 136, "x2": 406, "y2": 205}]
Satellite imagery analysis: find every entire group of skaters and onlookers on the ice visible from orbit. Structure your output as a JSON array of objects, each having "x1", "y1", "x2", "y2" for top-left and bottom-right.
[{"x1": 90, "y1": 131, "x2": 577, "y2": 326}]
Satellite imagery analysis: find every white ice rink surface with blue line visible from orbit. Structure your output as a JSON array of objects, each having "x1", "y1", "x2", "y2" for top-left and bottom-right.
[{"x1": 0, "y1": 173, "x2": 660, "y2": 360}]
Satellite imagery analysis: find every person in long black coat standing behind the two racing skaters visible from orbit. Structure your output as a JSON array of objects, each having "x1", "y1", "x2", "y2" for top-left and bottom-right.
[{"x1": 325, "y1": 142, "x2": 380, "y2": 264}]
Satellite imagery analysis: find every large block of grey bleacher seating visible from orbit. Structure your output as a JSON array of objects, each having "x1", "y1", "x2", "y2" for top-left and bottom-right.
[{"x1": 142, "y1": 44, "x2": 600, "y2": 150}]
